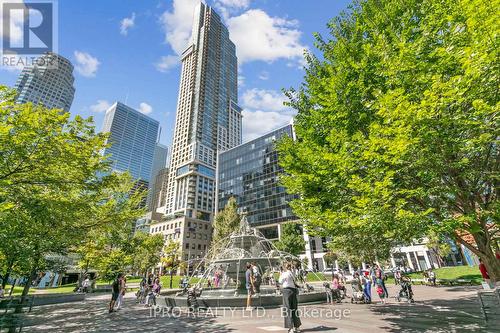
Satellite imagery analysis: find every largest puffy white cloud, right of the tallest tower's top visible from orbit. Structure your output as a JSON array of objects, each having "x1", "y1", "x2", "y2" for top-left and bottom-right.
[{"x1": 227, "y1": 9, "x2": 306, "y2": 63}]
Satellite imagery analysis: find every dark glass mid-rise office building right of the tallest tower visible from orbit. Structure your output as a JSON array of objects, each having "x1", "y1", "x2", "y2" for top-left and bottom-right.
[{"x1": 217, "y1": 125, "x2": 297, "y2": 238}]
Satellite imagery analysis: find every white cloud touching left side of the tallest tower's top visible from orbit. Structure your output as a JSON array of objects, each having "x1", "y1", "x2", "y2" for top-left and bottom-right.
[{"x1": 160, "y1": 0, "x2": 200, "y2": 55}]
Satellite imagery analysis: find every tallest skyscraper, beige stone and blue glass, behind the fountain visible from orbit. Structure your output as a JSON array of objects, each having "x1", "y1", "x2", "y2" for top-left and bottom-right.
[{"x1": 152, "y1": 3, "x2": 242, "y2": 259}]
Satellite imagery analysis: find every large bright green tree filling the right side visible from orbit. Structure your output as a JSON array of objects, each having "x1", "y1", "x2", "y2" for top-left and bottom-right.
[{"x1": 279, "y1": 0, "x2": 500, "y2": 280}]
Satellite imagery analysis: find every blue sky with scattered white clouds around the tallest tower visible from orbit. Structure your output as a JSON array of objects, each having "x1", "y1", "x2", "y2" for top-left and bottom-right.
[{"x1": 0, "y1": 0, "x2": 350, "y2": 145}]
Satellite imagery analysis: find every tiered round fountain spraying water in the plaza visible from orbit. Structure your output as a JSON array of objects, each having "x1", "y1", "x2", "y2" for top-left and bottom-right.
[{"x1": 165, "y1": 214, "x2": 326, "y2": 308}]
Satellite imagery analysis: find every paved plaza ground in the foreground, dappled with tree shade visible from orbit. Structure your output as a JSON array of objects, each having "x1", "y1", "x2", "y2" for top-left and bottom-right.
[{"x1": 5, "y1": 286, "x2": 499, "y2": 333}]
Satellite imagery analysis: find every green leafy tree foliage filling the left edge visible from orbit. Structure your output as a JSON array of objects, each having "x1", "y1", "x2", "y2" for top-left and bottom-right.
[{"x1": 0, "y1": 86, "x2": 146, "y2": 296}]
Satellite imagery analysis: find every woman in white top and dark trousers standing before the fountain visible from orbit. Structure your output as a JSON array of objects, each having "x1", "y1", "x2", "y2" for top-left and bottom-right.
[{"x1": 279, "y1": 263, "x2": 302, "y2": 333}]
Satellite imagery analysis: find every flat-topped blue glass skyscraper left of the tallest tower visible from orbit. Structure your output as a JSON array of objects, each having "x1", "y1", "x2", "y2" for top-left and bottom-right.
[{"x1": 102, "y1": 102, "x2": 160, "y2": 188}]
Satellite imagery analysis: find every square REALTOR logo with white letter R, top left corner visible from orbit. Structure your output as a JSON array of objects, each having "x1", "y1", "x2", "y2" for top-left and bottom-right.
[{"x1": 1, "y1": 1, "x2": 56, "y2": 55}]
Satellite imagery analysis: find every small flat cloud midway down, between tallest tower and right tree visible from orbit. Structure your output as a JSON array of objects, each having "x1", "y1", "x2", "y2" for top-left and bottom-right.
[{"x1": 242, "y1": 88, "x2": 289, "y2": 111}]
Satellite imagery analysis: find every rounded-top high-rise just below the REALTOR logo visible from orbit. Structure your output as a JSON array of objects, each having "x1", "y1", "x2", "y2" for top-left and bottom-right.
[{"x1": 16, "y1": 52, "x2": 75, "y2": 112}]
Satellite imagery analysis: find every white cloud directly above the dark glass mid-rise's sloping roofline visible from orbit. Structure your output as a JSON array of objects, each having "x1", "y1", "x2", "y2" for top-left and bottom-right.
[{"x1": 242, "y1": 109, "x2": 293, "y2": 142}]
